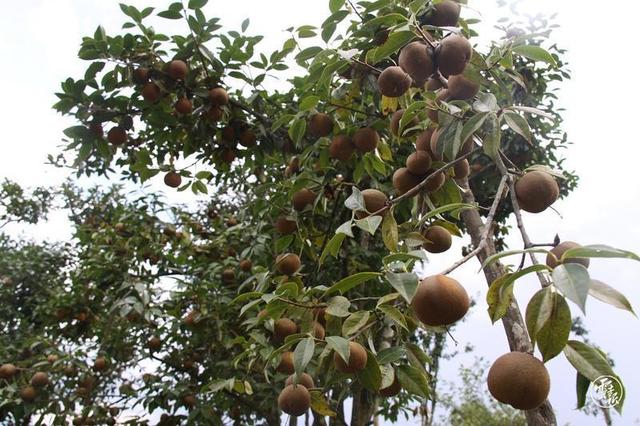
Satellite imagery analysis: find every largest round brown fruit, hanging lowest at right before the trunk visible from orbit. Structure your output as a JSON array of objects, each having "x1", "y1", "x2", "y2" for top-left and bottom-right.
[{"x1": 487, "y1": 352, "x2": 551, "y2": 410}]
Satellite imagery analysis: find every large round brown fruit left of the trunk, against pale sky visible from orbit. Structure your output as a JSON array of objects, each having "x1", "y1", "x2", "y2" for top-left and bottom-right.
[{"x1": 411, "y1": 275, "x2": 469, "y2": 326}]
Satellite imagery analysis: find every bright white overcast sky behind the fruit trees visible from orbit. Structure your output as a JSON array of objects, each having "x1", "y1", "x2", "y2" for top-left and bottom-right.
[{"x1": 0, "y1": 0, "x2": 640, "y2": 425}]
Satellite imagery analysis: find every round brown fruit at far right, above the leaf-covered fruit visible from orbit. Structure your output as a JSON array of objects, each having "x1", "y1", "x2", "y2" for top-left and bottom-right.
[{"x1": 516, "y1": 171, "x2": 560, "y2": 213}]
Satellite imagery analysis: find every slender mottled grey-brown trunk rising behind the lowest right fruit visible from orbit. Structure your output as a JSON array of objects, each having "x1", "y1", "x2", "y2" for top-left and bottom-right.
[{"x1": 458, "y1": 179, "x2": 557, "y2": 426}]
